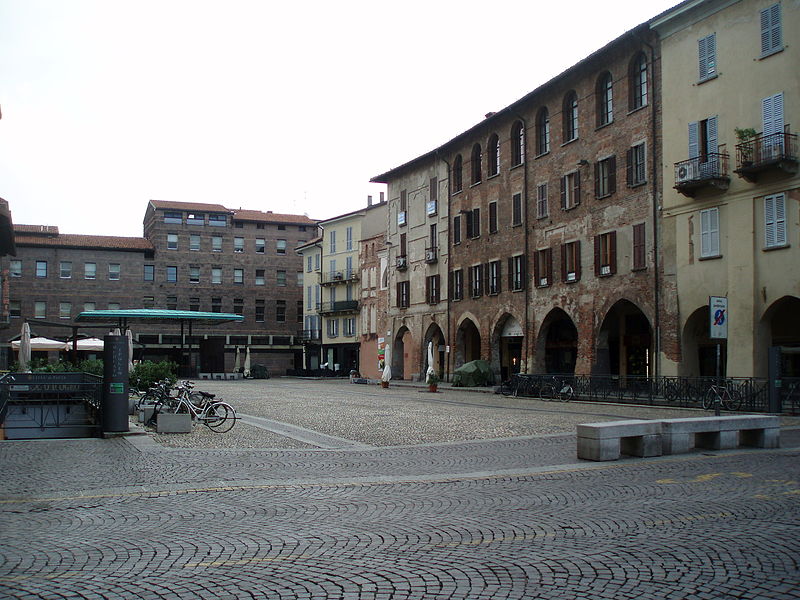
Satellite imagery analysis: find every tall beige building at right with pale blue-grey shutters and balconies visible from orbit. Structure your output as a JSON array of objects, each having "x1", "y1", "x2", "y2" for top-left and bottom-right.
[{"x1": 651, "y1": 0, "x2": 800, "y2": 377}]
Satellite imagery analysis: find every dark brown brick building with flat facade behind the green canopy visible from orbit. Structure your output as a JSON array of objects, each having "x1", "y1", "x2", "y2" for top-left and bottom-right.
[{"x1": 7, "y1": 200, "x2": 317, "y2": 373}]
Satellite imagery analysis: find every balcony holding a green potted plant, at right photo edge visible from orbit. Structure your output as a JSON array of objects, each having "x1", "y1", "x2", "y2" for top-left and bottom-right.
[{"x1": 734, "y1": 132, "x2": 797, "y2": 183}]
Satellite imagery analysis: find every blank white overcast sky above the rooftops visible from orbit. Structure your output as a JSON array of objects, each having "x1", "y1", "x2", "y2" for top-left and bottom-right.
[{"x1": 0, "y1": 0, "x2": 678, "y2": 236}]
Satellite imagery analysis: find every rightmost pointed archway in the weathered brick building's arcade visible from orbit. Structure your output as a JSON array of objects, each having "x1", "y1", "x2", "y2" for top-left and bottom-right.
[{"x1": 592, "y1": 298, "x2": 654, "y2": 377}]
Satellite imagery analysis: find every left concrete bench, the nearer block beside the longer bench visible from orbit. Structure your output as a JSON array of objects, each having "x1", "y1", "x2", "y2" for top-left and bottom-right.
[{"x1": 578, "y1": 419, "x2": 661, "y2": 461}]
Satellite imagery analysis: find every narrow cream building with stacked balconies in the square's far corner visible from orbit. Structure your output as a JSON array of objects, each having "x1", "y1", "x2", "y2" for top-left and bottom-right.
[{"x1": 297, "y1": 197, "x2": 386, "y2": 374}]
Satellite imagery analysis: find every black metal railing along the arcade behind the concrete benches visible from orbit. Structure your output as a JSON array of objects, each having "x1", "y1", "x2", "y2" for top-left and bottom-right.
[{"x1": 496, "y1": 374, "x2": 772, "y2": 412}]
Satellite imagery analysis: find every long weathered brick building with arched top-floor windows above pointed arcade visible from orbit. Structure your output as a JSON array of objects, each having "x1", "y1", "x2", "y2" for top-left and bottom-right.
[{"x1": 373, "y1": 25, "x2": 677, "y2": 378}]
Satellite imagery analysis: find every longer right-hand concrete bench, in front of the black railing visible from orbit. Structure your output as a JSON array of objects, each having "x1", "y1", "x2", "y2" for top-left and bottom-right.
[{"x1": 661, "y1": 415, "x2": 780, "y2": 454}]
